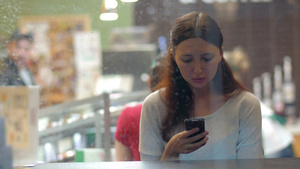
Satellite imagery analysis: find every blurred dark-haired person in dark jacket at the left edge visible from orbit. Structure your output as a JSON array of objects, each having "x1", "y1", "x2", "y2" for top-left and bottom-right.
[{"x1": 0, "y1": 29, "x2": 35, "y2": 86}]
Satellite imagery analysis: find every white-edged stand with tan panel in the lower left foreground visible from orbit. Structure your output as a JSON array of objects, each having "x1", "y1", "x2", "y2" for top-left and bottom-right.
[{"x1": 0, "y1": 86, "x2": 40, "y2": 166}]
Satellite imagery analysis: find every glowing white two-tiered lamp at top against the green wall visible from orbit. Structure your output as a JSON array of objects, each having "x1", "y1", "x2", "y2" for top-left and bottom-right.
[{"x1": 99, "y1": 0, "x2": 119, "y2": 21}]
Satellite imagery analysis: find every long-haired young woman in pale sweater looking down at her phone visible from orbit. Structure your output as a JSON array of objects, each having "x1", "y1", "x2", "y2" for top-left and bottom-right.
[{"x1": 139, "y1": 12, "x2": 263, "y2": 161}]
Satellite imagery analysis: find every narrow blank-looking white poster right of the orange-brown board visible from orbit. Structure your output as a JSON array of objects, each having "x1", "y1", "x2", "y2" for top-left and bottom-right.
[{"x1": 74, "y1": 32, "x2": 102, "y2": 99}]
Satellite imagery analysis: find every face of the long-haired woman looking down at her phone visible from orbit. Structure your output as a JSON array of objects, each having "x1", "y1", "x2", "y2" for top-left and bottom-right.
[{"x1": 173, "y1": 38, "x2": 223, "y2": 89}]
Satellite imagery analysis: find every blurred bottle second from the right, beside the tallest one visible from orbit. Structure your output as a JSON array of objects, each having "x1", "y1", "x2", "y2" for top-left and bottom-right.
[{"x1": 272, "y1": 65, "x2": 285, "y2": 116}]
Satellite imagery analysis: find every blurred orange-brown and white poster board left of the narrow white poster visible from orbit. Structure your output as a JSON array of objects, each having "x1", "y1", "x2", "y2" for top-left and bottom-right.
[{"x1": 19, "y1": 15, "x2": 90, "y2": 107}]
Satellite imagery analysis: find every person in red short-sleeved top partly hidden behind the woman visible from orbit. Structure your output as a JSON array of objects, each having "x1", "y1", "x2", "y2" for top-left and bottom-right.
[{"x1": 115, "y1": 56, "x2": 163, "y2": 161}]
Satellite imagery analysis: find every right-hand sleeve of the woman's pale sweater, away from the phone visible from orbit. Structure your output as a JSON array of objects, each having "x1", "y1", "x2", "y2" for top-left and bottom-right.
[{"x1": 237, "y1": 93, "x2": 263, "y2": 159}]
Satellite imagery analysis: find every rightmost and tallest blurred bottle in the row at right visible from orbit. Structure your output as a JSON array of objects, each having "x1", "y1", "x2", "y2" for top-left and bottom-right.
[{"x1": 283, "y1": 56, "x2": 296, "y2": 124}]
